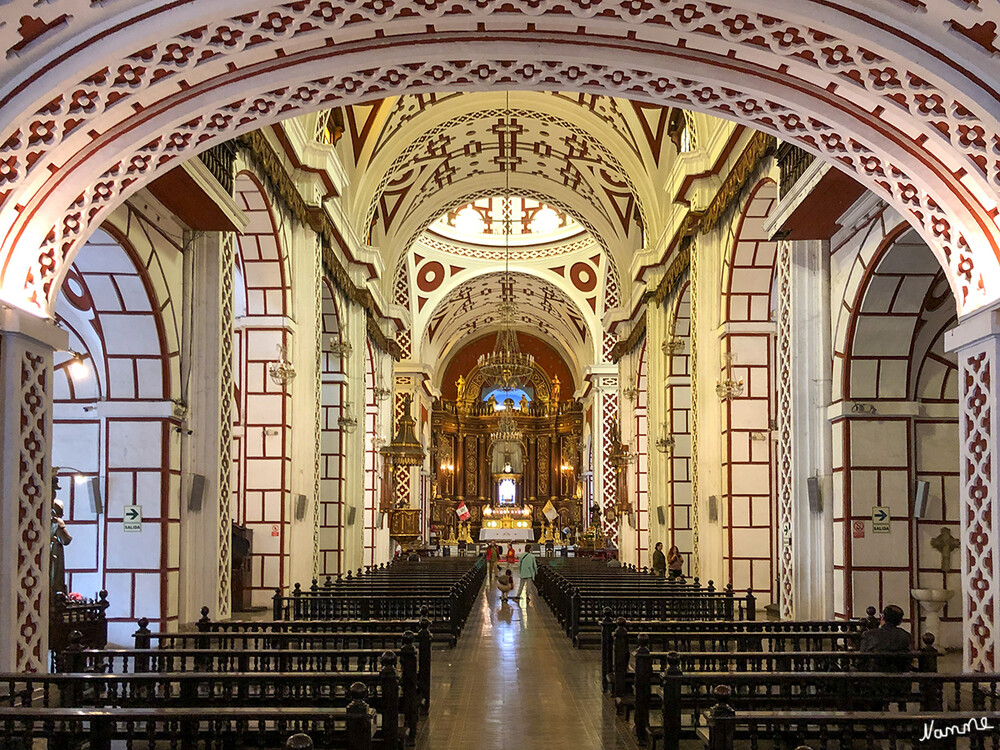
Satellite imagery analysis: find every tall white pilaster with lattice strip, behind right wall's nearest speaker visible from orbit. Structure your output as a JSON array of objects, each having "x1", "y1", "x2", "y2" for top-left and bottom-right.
[{"x1": 777, "y1": 241, "x2": 833, "y2": 620}]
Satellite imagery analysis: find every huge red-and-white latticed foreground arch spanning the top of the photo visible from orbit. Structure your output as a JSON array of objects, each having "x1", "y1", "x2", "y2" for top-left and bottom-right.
[{"x1": 0, "y1": 0, "x2": 1000, "y2": 315}]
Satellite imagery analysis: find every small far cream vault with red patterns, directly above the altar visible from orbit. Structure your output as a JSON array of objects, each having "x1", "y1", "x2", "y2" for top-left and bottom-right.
[{"x1": 422, "y1": 271, "x2": 594, "y2": 382}]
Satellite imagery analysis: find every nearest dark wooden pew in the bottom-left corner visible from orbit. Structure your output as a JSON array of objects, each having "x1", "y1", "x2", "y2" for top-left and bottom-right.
[{"x1": 0, "y1": 700, "x2": 385, "y2": 750}]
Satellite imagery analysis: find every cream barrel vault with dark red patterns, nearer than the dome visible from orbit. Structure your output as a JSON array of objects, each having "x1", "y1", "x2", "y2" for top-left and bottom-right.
[{"x1": 349, "y1": 92, "x2": 673, "y2": 262}]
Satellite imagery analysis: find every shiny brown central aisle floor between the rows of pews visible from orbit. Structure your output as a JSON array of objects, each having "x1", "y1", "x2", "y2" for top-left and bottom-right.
[{"x1": 417, "y1": 581, "x2": 637, "y2": 750}]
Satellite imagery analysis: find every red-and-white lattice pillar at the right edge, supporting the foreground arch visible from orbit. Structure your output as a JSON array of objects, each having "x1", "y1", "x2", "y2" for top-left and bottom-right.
[{"x1": 945, "y1": 308, "x2": 1000, "y2": 672}]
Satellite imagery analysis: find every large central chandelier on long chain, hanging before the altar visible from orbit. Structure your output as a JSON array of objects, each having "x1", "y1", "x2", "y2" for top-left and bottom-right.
[{"x1": 477, "y1": 92, "x2": 535, "y2": 390}]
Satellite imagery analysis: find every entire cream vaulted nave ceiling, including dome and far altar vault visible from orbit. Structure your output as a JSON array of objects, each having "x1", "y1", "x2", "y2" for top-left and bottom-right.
[{"x1": 324, "y1": 91, "x2": 676, "y2": 376}]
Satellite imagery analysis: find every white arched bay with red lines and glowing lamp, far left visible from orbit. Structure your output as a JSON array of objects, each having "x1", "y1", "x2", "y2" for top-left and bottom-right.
[{"x1": 53, "y1": 225, "x2": 181, "y2": 645}]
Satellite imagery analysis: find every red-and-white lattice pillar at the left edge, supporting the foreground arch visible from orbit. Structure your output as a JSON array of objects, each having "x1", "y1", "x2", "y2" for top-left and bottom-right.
[{"x1": 0, "y1": 307, "x2": 68, "y2": 672}]
